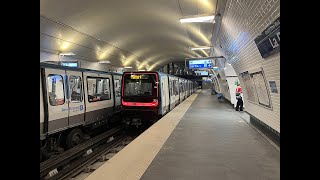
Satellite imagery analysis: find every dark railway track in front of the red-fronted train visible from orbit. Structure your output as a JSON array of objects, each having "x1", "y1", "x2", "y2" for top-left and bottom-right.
[{"x1": 40, "y1": 126, "x2": 130, "y2": 180}]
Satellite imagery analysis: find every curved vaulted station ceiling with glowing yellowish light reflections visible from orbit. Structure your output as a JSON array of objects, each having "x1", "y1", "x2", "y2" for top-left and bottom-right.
[{"x1": 40, "y1": 0, "x2": 217, "y2": 70}]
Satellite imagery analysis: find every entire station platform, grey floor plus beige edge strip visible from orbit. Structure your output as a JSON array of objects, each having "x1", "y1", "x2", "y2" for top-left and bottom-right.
[{"x1": 86, "y1": 90, "x2": 280, "y2": 180}]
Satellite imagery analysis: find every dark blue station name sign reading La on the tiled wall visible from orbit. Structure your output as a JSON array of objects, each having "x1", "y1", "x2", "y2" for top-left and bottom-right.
[{"x1": 254, "y1": 17, "x2": 280, "y2": 58}]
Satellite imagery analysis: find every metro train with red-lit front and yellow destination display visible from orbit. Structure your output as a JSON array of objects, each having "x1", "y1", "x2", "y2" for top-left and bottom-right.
[{"x1": 121, "y1": 71, "x2": 198, "y2": 126}]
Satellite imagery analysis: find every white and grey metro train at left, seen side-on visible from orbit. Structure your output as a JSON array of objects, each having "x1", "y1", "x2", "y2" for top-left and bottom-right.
[{"x1": 40, "y1": 63, "x2": 122, "y2": 159}]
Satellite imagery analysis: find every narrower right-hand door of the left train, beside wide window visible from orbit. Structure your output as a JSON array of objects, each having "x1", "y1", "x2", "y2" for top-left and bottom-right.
[{"x1": 67, "y1": 71, "x2": 84, "y2": 127}]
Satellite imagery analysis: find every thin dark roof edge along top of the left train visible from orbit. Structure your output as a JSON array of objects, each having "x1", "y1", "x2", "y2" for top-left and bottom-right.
[{"x1": 40, "y1": 62, "x2": 122, "y2": 76}]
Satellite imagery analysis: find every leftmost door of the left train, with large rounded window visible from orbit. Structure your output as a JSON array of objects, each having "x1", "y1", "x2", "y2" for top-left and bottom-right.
[{"x1": 45, "y1": 68, "x2": 69, "y2": 134}]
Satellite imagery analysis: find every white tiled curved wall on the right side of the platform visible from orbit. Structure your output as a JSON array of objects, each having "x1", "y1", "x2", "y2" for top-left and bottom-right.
[{"x1": 213, "y1": 0, "x2": 280, "y2": 133}]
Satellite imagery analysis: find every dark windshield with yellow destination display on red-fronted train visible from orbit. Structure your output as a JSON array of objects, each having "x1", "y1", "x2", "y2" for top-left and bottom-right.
[{"x1": 123, "y1": 74, "x2": 158, "y2": 102}]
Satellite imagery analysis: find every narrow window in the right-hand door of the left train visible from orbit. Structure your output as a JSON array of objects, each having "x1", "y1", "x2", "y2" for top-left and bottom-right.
[{"x1": 69, "y1": 76, "x2": 82, "y2": 102}]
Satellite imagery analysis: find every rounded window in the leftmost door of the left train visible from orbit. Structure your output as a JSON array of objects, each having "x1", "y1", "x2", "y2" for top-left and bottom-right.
[{"x1": 47, "y1": 74, "x2": 65, "y2": 106}]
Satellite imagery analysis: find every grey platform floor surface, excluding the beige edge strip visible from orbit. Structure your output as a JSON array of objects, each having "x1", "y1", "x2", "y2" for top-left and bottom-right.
[{"x1": 141, "y1": 91, "x2": 280, "y2": 180}]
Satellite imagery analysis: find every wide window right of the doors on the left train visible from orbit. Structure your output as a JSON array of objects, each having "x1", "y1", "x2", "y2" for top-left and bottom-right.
[{"x1": 87, "y1": 77, "x2": 111, "y2": 102}]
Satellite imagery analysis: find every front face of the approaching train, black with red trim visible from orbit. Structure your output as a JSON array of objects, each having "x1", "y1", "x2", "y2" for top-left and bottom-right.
[{"x1": 121, "y1": 72, "x2": 160, "y2": 125}]
